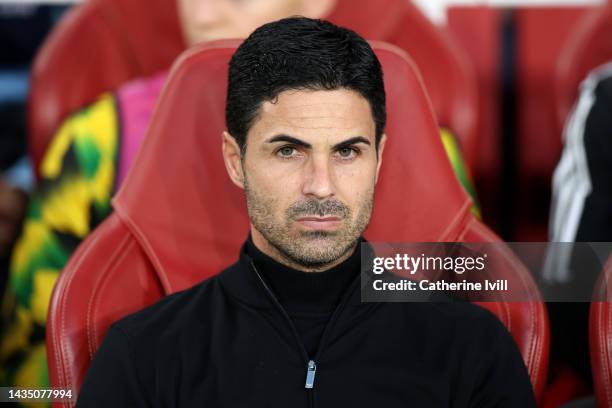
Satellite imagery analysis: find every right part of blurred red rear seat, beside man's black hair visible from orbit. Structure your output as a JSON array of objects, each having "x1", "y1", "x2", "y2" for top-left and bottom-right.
[{"x1": 330, "y1": 0, "x2": 480, "y2": 169}]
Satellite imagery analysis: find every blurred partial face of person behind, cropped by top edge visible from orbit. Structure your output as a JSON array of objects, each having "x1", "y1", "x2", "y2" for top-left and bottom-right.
[{"x1": 177, "y1": 0, "x2": 336, "y2": 46}]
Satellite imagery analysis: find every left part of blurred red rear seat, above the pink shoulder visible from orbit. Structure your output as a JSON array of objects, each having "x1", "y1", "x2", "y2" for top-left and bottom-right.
[{"x1": 28, "y1": 0, "x2": 185, "y2": 175}]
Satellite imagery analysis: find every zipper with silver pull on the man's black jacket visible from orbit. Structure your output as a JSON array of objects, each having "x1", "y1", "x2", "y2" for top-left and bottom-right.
[{"x1": 251, "y1": 261, "x2": 359, "y2": 407}]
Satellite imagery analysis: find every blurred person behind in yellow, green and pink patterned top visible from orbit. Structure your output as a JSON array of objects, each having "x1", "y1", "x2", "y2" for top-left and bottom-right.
[{"x1": 0, "y1": 0, "x2": 336, "y2": 396}]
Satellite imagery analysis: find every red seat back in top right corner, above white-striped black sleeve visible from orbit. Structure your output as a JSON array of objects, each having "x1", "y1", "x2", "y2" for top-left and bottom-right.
[{"x1": 555, "y1": 2, "x2": 612, "y2": 139}]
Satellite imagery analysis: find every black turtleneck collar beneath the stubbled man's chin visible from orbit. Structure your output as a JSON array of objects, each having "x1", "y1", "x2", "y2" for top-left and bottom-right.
[{"x1": 246, "y1": 234, "x2": 361, "y2": 312}]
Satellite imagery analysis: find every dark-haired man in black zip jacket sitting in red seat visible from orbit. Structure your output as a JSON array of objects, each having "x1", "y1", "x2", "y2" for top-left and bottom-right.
[{"x1": 77, "y1": 18, "x2": 534, "y2": 407}]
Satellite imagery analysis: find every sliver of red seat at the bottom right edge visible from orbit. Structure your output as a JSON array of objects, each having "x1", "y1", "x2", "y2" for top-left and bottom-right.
[{"x1": 589, "y1": 257, "x2": 612, "y2": 407}]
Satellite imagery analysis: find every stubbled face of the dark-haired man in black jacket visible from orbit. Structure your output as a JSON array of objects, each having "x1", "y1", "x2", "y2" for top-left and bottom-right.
[{"x1": 224, "y1": 89, "x2": 384, "y2": 270}]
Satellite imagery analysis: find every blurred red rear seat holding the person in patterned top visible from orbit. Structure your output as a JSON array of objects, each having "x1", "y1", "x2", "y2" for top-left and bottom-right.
[{"x1": 28, "y1": 0, "x2": 478, "y2": 178}]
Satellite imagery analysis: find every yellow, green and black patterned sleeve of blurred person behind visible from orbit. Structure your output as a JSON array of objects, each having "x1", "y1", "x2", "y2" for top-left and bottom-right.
[{"x1": 0, "y1": 93, "x2": 119, "y2": 406}]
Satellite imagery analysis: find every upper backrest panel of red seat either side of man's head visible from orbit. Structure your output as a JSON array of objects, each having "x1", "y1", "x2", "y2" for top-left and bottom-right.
[{"x1": 113, "y1": 41, "x2": 471, "y2": 292}]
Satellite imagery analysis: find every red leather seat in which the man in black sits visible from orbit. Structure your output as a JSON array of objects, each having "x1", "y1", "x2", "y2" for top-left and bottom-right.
[{"x1": 47, "y1": 41, "x2": 548, "y2": 404}]
